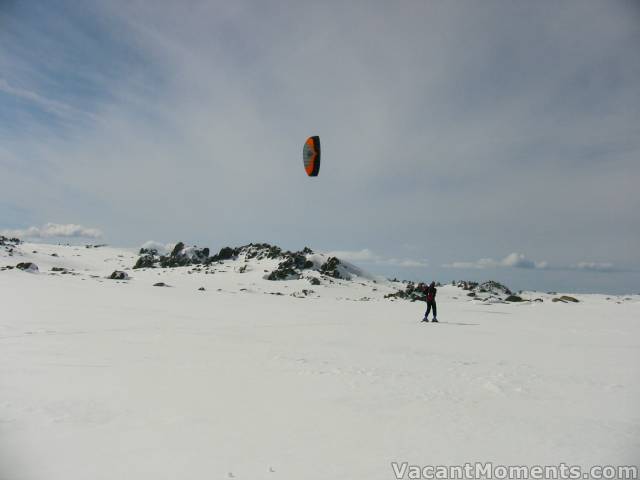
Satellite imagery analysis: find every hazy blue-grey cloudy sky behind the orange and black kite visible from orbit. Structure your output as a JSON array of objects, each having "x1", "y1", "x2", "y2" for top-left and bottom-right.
[{"x1": 0, "y1": 0, "x2": 640, "y2": 293}]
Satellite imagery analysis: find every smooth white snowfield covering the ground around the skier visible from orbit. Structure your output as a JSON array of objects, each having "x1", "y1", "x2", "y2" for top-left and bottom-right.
[{"x1": 0, "y1": 244, "x2": 640, "y2": 480}]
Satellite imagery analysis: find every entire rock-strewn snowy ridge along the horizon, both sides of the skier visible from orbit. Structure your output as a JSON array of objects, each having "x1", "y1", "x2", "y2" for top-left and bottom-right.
[{"x1": 0, "y1": 237, "x2": 638, "y2": 305}]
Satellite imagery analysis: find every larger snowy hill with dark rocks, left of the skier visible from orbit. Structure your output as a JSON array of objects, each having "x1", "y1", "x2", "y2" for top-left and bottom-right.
[{"x1": 0, "y1": 242, "x2": 400, "y2": 300}]
